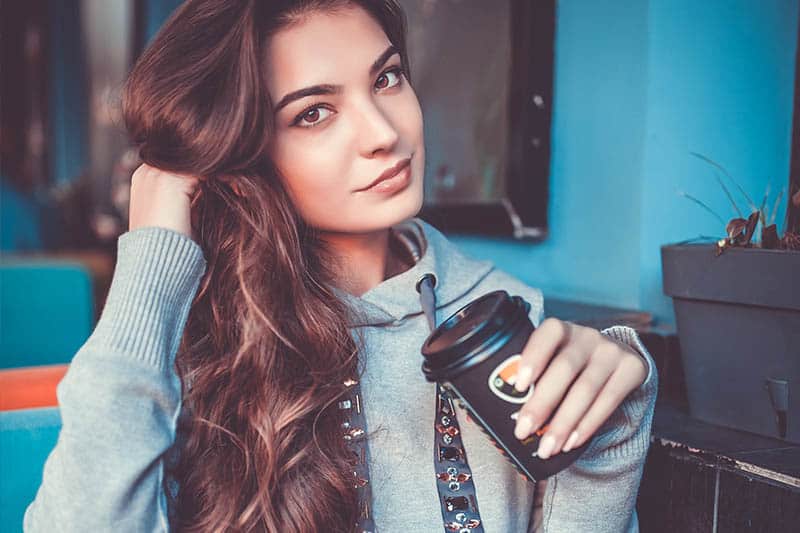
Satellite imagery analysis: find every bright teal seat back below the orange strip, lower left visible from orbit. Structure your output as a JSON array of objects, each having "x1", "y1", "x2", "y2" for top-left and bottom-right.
[{"x1": 0, "y1": 407, "x2": 61, "y2": 531}]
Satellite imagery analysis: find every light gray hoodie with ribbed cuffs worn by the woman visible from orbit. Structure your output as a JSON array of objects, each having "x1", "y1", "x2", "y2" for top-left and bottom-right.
[{"x1": 24, "y1": 218, "x2": 658, "y2": 533}]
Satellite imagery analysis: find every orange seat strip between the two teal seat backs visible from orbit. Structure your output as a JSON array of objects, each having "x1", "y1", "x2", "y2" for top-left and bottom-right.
[{"x1": 0, "y1": 365, "x2": 69, "y2": 411}]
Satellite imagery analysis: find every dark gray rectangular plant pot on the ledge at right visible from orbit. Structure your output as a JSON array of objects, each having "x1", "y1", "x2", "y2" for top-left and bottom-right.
[{"x1": 661, "y1": 244, "x2": 800, "y2": 443}]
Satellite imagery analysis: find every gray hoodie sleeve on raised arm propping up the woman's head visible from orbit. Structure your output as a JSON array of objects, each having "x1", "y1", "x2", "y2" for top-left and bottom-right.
[{"x1": 24, "y1": 227, "x2": 206, "y2": 532}]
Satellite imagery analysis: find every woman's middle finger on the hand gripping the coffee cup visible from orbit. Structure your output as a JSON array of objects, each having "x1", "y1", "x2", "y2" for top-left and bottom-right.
[{"x1": 514, "y1": 346, "x2": 587, "y2": 439}]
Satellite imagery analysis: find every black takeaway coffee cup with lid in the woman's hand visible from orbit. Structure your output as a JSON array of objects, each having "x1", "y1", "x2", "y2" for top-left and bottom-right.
[{"x1": 422, "y1": 290, "x2": 591, "y2": 481}]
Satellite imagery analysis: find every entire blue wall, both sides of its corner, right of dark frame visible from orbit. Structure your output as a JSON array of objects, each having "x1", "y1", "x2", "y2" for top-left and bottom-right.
[{"x1": 454, "y1": 0, "x2": 800, "y2": 323}]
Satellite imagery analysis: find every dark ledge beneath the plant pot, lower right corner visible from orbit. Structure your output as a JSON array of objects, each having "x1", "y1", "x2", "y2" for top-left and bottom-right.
[{"x1": 637, "y1": 402, "x2": 800, "y2": 533}]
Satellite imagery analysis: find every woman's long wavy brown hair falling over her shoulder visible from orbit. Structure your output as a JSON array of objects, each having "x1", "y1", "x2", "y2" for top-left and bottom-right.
[{"x1": 123, "y1": 0, "x2": 407, "y2": 532}]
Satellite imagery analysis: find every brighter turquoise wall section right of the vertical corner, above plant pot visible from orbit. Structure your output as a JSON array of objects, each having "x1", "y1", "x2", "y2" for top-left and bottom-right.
[{"x1": 639, "y1": 0, "x2": 800, "y2": 315}]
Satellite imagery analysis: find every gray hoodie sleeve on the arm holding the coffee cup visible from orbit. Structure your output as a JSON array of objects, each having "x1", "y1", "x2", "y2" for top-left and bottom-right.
[{"x1": 542, "y1": 326, "x2": 658, "y2": 533}]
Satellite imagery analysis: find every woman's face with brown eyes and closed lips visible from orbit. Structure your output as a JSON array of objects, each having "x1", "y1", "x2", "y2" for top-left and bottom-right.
[{"x1": 267, "y1": 7, "x2": 425, "y2": 233}]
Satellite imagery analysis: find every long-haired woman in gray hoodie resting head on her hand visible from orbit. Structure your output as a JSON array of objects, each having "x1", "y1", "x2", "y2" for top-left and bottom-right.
[{"x1": 25, "y1": 0, "x2": 657, "y2": 532}]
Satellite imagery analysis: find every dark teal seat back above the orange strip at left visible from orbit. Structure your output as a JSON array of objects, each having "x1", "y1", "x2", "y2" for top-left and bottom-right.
[{"x1": 0, "y1": 259, "x2": 94, "y2": 368}]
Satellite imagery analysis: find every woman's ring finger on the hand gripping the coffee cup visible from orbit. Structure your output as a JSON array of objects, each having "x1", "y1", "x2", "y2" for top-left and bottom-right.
[{"x1": 538, "y1": 358, "x2": 614, "y2": 459}]
